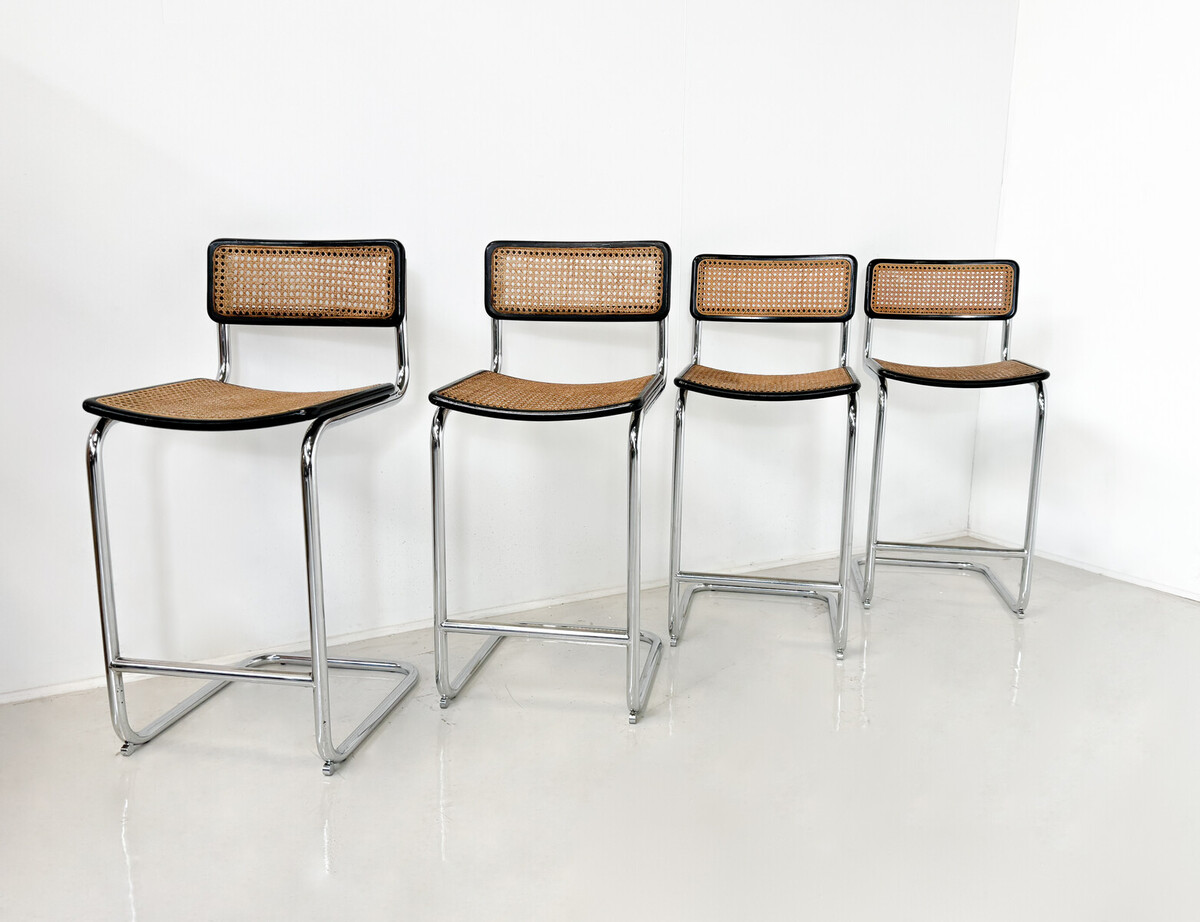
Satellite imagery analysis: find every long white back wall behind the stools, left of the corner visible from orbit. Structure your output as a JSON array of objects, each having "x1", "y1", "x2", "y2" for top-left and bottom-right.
[{"x1": 0, "y1": 0, "x2": 1034, "y2": 696}]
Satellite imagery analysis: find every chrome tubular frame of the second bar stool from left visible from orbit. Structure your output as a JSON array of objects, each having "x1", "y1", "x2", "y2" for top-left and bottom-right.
[{"x1": 430, "y1": 319, "x2": 666, "y2": 724}]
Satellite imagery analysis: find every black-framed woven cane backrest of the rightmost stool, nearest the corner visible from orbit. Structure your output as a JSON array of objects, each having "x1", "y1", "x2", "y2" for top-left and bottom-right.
[{"x1": 866, "y1": 259, "x2": 1018, "y2": 319}]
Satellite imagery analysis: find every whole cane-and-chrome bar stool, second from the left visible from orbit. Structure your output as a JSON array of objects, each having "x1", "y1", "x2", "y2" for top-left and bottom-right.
[{"x1": 430, "y1": 240, "x2": 671, "y2": 724}]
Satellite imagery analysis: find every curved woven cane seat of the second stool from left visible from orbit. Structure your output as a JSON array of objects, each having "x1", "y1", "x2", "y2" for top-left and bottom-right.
[{"x1": 430, "y1": 371, "x2": 654, "y2": 419}]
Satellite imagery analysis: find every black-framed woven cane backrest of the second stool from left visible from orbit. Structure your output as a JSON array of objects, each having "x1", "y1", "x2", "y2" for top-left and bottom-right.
[{"x1": 485, "y1": 241, "x2": 671, "y2": 321}]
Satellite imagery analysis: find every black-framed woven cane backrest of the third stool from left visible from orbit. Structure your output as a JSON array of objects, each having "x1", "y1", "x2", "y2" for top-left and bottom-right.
[{"x1": 691, "y1": 256, "x2": 856, "y2": 321}]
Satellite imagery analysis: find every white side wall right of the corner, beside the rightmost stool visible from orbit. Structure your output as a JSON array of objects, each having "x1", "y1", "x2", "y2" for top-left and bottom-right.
[{"x1": 971, "y1": 0, "x2": 1200, "y2": 604}]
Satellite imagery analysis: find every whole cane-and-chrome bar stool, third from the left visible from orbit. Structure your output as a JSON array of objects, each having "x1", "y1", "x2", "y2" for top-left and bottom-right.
[{"x1": 667, "y1": 255, "x2": 859, "y2": 659}]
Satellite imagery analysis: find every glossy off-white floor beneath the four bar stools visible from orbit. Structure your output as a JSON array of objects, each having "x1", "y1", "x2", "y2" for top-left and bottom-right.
[{"x1": 0, "y1": 561, "x2": 1200, "y2": 921}]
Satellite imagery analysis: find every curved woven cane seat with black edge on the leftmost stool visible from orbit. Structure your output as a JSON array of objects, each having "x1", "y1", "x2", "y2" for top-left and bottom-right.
[{"x1": 84, "y1": 378, "x2": 395, "y2": 430}]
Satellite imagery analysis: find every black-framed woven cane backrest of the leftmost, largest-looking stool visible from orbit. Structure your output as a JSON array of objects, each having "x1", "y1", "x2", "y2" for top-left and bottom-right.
[{"x1": 209, "y1": 240, "x2": 404, "y2": 327}]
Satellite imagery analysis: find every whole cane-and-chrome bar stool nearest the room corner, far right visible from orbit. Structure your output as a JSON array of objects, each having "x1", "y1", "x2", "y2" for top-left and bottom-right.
[{"x1": 854, "y1": 259, "x2": 1050, "y2": 618}]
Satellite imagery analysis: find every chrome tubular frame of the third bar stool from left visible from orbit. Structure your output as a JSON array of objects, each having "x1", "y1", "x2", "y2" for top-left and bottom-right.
[{"x1": 667, "y1": 319, "x2": 858, "y2": 659}]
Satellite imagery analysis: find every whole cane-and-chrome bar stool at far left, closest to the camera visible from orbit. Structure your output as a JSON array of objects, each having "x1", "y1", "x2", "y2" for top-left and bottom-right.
[{"x1": 83, "y1": 239, "x2": 418, "y2": 774}]
